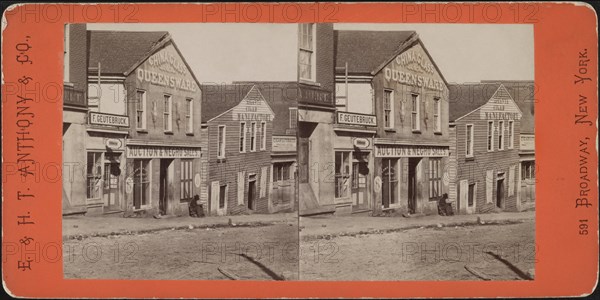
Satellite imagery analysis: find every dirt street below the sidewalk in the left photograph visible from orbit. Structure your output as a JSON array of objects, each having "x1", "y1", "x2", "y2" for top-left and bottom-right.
[{"x1": 63, "y1": 222, "x2": 298, "y2": 280}]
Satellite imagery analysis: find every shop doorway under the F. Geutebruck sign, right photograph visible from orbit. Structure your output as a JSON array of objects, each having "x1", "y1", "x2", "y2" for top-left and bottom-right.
[{"x1": 350, "y1": 152, "x2": 369, "y2": 211}]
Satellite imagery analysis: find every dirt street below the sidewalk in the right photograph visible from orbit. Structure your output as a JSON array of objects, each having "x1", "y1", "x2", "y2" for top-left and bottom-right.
[{"x1": 300, "y1": 220, "x2": 535, "y2": 281}]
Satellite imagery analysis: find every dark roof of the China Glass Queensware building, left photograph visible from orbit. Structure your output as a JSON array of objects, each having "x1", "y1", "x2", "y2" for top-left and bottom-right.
[{"x1": 87, "y1": 30, "x2": 170, "y2": 75}]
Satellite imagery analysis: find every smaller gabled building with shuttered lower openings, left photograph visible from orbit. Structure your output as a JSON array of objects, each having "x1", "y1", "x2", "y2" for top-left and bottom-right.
[{"x1": 202, "y1": 85, "x2": 274, "y2": 215}]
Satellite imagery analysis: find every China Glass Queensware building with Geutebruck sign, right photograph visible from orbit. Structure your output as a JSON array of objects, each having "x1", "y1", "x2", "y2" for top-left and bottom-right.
[{"x1": 334, "y1": 31, "x2": 450, "y2": 214}]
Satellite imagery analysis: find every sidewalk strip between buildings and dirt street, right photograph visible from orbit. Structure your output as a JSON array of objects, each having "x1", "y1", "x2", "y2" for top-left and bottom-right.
[{"x1": 300, "y1": 211, "x2": 535, "y2": 238}]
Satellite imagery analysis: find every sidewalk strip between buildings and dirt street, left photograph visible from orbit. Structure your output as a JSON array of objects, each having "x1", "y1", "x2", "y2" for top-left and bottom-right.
[{"x1": 62, "y1": 213, "x2": 297, "y2": 239}]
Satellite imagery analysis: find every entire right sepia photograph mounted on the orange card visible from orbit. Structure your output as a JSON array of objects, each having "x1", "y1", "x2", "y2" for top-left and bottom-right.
[{"x1": 297, "y1": 23, "x2": 540, "y2": 281}]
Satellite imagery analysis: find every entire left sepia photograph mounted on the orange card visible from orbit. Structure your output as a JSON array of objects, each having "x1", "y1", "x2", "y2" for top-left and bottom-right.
[{"x1": 62, "y1": 24, "x2": 303, "y2": 280}]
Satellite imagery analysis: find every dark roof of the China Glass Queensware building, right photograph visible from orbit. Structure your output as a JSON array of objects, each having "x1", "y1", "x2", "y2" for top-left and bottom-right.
[{"x1": 334, "y1": 30, "x2": 415, "y2": 75}]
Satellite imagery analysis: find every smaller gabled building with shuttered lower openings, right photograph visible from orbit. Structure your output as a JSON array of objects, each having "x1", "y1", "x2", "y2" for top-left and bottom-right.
[{"x1": 449, "y1": 83, "x2": 523, "y2": 214}]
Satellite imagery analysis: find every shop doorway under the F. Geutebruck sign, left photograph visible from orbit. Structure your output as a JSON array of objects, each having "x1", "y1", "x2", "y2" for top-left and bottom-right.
[{"x1": 102, "y1": 153, "x2": 121, "y2": 212}]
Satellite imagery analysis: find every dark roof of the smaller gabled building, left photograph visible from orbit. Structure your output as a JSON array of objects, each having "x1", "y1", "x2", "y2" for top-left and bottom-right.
[{"x1": 200, "y1": 84, "x2": 275, "y2": 123}]
